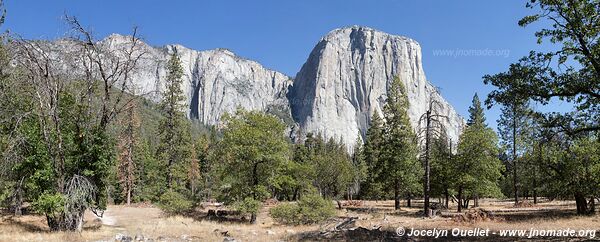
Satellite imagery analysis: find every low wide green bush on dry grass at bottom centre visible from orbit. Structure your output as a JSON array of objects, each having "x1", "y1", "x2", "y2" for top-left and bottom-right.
[{"x1": 270, "y1": 194, "x2": 335, "y2": 225}]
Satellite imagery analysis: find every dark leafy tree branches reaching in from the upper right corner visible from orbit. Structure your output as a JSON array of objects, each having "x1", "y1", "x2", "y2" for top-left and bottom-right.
[{"x1": 484, "y1": 0, "x2": 600, "y2": 134}]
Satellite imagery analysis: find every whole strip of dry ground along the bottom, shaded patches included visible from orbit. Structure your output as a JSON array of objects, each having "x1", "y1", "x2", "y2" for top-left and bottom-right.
[{"x1": 0, "y1": 200, "x2": 600, "y2": 241}]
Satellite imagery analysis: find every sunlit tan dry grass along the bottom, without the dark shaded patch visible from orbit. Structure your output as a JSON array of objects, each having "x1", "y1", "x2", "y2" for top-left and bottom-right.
[{"x1": 0, "y1": 200, "x2": 600, "y2": 241}]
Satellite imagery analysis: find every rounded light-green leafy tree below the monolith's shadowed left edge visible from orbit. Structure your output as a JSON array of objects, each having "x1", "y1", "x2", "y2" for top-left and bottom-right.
[{"x1": 215, "y1": 110, "x2": 290, "y2": 221}]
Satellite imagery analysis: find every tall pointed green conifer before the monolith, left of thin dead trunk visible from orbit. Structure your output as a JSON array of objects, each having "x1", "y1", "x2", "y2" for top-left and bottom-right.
[{"x1": 360, "y1": 77, "x2": 423, "y2": 205}]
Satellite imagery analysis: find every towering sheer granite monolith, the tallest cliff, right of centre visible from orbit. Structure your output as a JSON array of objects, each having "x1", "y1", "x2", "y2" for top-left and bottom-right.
[{"x1": 288, "y1": 26, "x2": 464, "y2": 150}]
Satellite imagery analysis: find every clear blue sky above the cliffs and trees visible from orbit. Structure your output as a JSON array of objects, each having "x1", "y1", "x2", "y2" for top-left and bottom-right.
[{"x1": 2, "y1": 0, "x2": 564, "y2": 130}]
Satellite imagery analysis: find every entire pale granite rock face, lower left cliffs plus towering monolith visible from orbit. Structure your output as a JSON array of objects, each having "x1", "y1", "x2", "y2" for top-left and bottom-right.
[{"x1": 44, "y1": 26, "x2": 464, "y2": 151}]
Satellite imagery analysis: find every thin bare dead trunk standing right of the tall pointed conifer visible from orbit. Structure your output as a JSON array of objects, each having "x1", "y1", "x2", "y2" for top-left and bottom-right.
[{"x1": 418, "y1": 90, "x2": 448, "y2": 217}]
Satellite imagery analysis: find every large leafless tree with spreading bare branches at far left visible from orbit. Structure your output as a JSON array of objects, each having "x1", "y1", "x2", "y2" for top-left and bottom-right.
[{"x1": 13, "y1": 16, "x2": 145, "y2": 230}]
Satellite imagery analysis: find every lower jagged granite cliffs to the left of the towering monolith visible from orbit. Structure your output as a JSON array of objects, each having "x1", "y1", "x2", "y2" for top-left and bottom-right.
[{"x1": 29, "y1": 34, "x2": 293, "y2": 130}]
